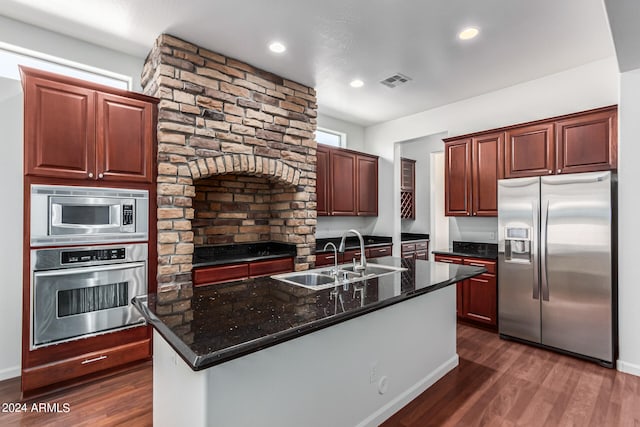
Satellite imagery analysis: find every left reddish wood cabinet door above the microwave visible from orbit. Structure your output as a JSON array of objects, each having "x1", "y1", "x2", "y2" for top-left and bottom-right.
[{"x1": 23, "y1": 74, "x2": 95, "y2": 179}]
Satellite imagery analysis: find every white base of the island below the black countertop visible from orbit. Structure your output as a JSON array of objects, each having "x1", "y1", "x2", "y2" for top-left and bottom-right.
[{"x1": 153, "y1": 286, "x2": 458, "y2": 427}]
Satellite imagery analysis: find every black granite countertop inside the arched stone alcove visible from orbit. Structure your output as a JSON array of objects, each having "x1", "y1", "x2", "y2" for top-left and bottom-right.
[{"x1": 193, "y1": 242, "x2": 296, "y2": 268}]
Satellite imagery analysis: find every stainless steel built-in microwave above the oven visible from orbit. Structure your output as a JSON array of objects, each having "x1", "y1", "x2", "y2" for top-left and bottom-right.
[{"x1": 31, "y1": 185, "x2": 149, "y2": 246}]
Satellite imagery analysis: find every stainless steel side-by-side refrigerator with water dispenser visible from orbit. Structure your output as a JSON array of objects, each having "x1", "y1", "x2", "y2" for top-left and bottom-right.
[{"x1": 498, "y1": 172, "x2": 617, "y2": 367}]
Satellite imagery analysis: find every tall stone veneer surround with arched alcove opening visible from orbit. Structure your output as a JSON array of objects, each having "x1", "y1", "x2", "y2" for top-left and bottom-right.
[{"x1": 142, "y1": 34, "x2": 317, "y2": 289}]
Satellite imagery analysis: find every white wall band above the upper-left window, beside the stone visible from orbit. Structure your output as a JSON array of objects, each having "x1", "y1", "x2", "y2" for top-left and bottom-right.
[{"x1": 0, "y1": 16, "x2": 144, "y2": 92}]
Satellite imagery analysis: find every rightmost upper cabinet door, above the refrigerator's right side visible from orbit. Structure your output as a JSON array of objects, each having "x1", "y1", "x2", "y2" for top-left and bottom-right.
[{"x1": 555, "y1": 109, "x2": 618, "y2": 173}]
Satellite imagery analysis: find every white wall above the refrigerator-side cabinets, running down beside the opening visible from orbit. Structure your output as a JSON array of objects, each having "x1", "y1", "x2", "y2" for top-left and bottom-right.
[{"x1": 365, "y1": 57, "x2": 619, "y2": 235}]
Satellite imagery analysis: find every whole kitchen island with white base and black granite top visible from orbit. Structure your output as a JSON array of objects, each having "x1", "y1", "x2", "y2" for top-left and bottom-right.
[{"x1": 134, "y1": 257, "x2": 485, "y2": 426}]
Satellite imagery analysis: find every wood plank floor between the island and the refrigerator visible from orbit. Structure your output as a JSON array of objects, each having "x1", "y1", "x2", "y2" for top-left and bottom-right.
[{"x1": 383, "y1": 325, "x2": 640, "y2": 427}]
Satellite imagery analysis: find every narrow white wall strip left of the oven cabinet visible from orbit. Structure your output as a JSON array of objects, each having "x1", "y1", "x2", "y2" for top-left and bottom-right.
[{"x1": 0, "y1": 83, "x2": 23, "y2": 381}]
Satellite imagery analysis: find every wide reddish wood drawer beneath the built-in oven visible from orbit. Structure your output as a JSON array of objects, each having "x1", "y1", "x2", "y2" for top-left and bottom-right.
[{"x1": 22, "y1": 339, "x2": 151, "y2": 391}]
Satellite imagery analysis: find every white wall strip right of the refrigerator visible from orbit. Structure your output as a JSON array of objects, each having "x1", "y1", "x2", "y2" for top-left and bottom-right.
[{"x1": 618, "y1": 69, "x2": 640, "y2": 375}]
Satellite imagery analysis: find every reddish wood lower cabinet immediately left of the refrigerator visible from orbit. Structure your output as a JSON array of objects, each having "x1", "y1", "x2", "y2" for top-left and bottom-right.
[{"x1": 435, "y1": 255, "x2": 498, "y2": 328}]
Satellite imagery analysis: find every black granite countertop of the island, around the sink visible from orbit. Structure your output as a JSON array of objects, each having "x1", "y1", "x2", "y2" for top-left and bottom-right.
[{"x1": 133, "y1": 257, "x2": 486, "y2": 371}]
